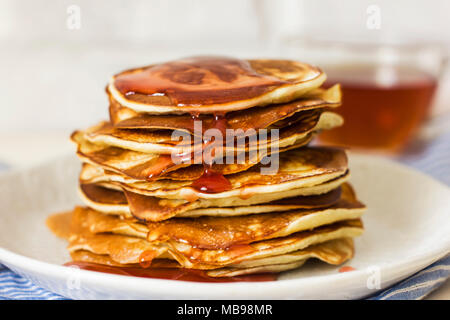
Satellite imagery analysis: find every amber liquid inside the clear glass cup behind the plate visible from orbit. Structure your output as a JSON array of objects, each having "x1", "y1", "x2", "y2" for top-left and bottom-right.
[{"x1": 320, "y1": 66, "x2": 437, "y2": 152}]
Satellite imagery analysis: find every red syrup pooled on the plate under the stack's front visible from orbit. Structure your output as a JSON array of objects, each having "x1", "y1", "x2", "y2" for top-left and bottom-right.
[{"x1": 64, "y1": 261, "x2": 277, "y2": 282}]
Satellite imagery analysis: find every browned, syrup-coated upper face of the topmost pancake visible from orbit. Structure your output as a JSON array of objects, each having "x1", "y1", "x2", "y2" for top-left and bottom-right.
[{"x1": 113, "y1": 57, "x2": 322, "y2": 109}]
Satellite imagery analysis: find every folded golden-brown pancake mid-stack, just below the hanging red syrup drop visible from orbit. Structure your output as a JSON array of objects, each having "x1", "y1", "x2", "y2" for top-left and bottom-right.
[{"x1": 79, "y1": 174, "x2": 349, "y2": 221}]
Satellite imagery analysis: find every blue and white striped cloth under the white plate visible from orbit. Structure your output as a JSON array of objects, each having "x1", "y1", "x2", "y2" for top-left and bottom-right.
[{"x1": 0, "y1": 133, "x2": 450, "y2": 300}]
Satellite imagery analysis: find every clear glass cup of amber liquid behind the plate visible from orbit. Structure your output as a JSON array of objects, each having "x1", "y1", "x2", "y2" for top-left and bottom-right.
[{"x1": 284, "y1": 39, "x2": 446, "y2": 153}]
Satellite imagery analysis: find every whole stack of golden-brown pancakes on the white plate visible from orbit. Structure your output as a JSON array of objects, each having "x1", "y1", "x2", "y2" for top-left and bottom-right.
[{"x1": 48, "y1": 57, "x2": 365, "y2": 277}]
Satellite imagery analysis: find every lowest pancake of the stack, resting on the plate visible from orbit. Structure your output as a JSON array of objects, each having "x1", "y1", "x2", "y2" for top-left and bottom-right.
[{"x1": 71, "y1": 238, "x2": 354, "y2": 277}]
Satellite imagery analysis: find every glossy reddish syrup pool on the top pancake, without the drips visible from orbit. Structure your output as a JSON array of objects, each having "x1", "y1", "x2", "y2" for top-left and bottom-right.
[{"x1": 114, "y1": 56, "x2": 286, "y2": 107}]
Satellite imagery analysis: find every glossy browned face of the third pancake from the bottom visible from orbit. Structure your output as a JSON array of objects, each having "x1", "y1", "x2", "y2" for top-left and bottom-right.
[{"x1": 142, "y1": 185, "x2": 365, "y2": 249}]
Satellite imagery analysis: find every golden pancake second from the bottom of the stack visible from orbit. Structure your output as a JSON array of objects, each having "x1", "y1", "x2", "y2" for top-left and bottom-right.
[{"x1": 63, "y1": 207, "x2": 363, "y2": 269}]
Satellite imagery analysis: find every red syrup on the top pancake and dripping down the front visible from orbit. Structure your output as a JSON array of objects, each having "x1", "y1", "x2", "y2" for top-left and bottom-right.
[{"x1": 115, "y1": 57, "x2": 255, "y2": 193}]
